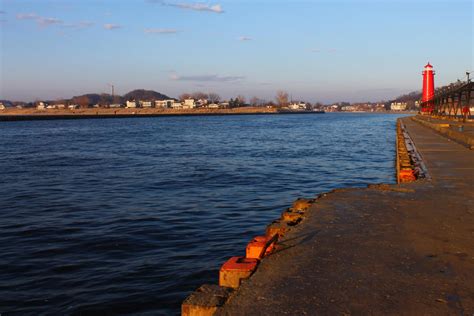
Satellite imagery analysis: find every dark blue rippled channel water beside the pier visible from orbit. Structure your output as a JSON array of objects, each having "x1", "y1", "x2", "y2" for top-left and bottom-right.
[{"x1": 0, "y1": 114, "x2": 404, "y2": 315}]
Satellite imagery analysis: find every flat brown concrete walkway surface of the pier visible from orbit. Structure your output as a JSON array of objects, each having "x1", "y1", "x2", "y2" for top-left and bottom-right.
[{"x1": 217, "y1": 118, "x2": 474, "y2": 315}]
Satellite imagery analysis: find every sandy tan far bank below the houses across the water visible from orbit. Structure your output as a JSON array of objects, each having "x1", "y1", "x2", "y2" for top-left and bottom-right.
[{"x1": 0, "y1": 107, "x2": 413, "y2": 122}]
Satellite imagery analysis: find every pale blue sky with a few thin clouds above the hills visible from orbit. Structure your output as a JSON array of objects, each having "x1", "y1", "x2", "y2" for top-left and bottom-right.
[{"x1": 0, "y1": 0, "x2": 474, "y2": 103}]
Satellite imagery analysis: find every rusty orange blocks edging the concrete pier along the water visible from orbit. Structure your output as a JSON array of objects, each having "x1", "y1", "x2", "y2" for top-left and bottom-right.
[{"x1": 181, "y1": 117, "x2": 430, "y2": 316}]
